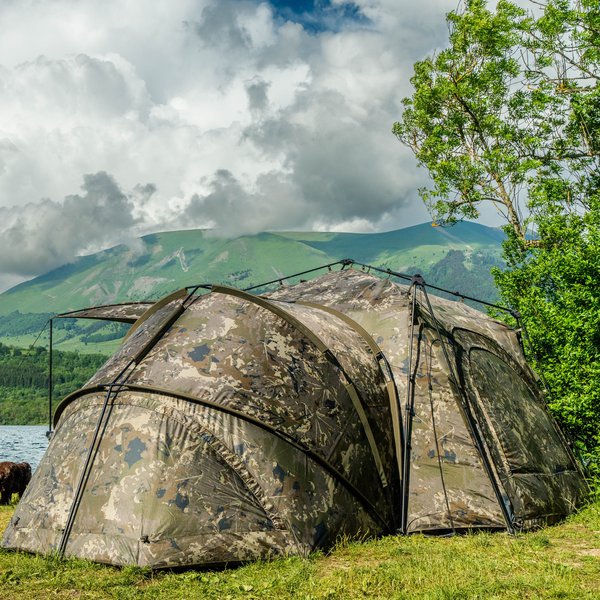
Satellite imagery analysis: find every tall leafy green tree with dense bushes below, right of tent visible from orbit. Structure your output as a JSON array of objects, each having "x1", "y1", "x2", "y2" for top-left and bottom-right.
[{"x1": 393, "y1": 0, "x2": 600, "y2": 469}]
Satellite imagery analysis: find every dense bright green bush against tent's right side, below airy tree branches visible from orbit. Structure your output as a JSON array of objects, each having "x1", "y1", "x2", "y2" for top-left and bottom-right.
[{"x1": 495, "y1": 203, "x2": 600, "y2": 469}]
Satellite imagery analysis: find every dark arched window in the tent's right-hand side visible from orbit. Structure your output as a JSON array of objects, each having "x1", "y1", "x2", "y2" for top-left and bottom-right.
[{"x1": 469, "y1": 348, "x2": 573, "y2": 474}]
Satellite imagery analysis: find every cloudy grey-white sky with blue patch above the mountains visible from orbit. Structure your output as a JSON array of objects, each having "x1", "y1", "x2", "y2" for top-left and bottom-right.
[{"x1": 0, "y1": 0, "x2": 464, "y2": 291}]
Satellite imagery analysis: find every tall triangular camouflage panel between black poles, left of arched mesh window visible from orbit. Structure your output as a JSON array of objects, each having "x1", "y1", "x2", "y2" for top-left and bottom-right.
[{"x1": 407, "y1": 329, "x2": 506, "y2": 532}]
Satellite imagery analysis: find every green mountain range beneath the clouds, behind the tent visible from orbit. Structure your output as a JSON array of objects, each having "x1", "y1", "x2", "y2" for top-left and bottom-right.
[{"x1": 0, "y1": 222, "x2": 504, "y2": 351}]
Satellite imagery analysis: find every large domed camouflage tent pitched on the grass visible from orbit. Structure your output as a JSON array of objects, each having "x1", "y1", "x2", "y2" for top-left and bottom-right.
[{"x1": 2, "y1": 269, "x2": 586, "y2": 567}]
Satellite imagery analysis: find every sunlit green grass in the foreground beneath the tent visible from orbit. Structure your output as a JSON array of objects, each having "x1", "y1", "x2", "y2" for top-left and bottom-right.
[{"x1": 0, "y1": 501, "x2": 600, "y2": 600}]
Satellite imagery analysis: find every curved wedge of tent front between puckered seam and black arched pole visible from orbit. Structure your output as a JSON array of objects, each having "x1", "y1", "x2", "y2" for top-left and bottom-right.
[{"x1": 110, "y1": 394, "x2": 381, "y2": 555}]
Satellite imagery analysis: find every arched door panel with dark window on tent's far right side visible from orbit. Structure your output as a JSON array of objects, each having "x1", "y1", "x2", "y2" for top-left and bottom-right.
[{"x1": 455, "y1": 330, "x2": 576, "y2": 528}]
